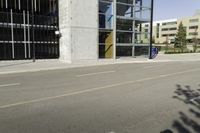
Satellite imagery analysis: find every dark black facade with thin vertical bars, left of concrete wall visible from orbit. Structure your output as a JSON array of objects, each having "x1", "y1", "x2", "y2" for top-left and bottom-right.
[{"x1": 0, "y1": 0, "x2": 59, "y2": 60}]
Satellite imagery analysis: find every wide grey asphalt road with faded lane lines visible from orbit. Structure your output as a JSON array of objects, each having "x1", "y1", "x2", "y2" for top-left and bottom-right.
[{"x1": 0, "y1": 62, "x2": 200, "y2": 133}]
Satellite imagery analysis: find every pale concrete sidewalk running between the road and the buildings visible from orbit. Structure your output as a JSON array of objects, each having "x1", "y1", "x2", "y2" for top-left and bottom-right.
[{"x1": 0, "y1": 54, "x2": 200, "y2": 75}]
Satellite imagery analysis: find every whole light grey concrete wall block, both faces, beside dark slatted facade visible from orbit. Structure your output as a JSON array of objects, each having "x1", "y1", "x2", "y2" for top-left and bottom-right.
[{"x1": 59, "y1": 0, "x2": 98, "y2": 63}]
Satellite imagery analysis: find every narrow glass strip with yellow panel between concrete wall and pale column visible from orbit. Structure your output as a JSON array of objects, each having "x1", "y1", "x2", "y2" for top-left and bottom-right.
[{"x1": 99, "y1": 0, "x2": 113, "y2": 58}]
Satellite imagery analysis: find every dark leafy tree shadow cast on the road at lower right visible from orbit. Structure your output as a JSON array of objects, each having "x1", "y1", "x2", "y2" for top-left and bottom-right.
[{"x1": 166, "y1": 85, "x2": 200, "y2": 133}]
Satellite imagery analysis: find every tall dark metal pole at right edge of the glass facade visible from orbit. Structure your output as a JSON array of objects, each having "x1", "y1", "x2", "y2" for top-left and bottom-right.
[{"x1": 149, "y1": 0, "x2": 154, "y2": 59}]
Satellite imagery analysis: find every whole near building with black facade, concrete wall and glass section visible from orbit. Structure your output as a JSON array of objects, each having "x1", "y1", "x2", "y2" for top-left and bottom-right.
[{"x1": 0, "y1": 0, "x2": 151, "y2": 63}]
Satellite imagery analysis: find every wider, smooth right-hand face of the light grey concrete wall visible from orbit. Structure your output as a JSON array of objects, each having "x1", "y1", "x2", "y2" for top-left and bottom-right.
[{"x1": 71, "y1": 0, "x2": 98, "y2": 61}]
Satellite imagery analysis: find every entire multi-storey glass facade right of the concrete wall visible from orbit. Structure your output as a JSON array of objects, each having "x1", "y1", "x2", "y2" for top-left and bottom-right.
[{"x1": 99, "y1": 0, "x2": 151, "y2": 58}]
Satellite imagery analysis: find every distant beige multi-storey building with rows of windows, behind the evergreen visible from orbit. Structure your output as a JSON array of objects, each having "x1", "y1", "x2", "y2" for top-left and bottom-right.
[{"x1": 153, "y1": 16, "x2": 200, "y2": 43}]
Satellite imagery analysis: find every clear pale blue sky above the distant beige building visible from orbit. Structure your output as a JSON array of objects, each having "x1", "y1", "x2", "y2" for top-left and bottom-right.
[{"x1": 154, "y1": 0, "x2": 200, "y2": 20}]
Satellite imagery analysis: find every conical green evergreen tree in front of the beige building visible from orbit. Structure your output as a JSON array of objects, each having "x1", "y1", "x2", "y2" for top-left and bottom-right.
[{"x1": 174, "y1": 22, "x2": 187, "y2": 52}]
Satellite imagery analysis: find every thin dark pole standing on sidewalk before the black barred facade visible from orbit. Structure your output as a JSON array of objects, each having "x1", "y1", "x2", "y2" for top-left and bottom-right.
[{"x1": 32, "y1": 0, "x2": 35, "y2": 62}]
